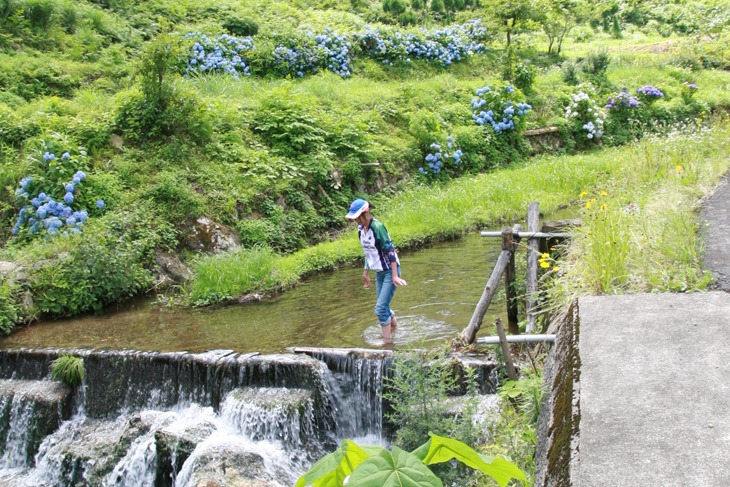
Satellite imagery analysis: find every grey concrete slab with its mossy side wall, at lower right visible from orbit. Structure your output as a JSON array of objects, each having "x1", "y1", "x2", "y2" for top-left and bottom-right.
[{"x1": 535, "y1": 292, "x2": 730, "y2": 487}]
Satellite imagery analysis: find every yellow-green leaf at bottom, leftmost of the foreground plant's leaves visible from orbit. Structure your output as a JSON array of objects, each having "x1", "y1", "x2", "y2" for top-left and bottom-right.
[{"x1": 296, "y1": 440, "x2": 387, "y2": 487}]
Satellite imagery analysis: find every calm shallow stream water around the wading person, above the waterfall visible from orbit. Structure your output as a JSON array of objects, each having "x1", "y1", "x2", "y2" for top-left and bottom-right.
[{"x1": 0, "y1": 234, "x2": 506, "y2": 353}]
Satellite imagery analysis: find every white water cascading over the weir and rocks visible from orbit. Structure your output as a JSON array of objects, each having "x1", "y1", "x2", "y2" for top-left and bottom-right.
[{"x1": 0, "y1": 351, "x2": 404, "y2": 487}]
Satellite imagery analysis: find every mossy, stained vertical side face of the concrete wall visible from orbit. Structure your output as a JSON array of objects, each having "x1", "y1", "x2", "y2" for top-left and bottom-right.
[{"x1": 534, "y1": 302, "x2": 580, "y2": 487}]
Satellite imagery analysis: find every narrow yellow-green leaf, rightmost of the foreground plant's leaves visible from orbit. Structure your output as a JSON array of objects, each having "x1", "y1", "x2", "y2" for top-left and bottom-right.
[{"x1": 414, "y1": 433, "x2": 527, "y2": 487}]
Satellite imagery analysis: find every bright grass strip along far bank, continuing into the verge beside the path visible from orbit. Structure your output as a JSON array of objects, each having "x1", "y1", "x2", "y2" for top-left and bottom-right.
[{"x1": 187, "y1": 124, "x2": 730, "y2": 304}]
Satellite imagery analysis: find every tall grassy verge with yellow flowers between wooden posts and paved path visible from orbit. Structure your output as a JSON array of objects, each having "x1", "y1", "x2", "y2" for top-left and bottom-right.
[{"x1": 548, "y1": 124, "x2": 730, "y2": 305}]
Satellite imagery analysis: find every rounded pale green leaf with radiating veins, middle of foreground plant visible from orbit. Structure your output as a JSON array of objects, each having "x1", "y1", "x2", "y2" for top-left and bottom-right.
[{"x1": 347, "y1": 446, "x2": 443, "y2": 487}]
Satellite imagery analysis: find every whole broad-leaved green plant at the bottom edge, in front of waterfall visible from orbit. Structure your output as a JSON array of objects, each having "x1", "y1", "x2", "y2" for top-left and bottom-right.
[{"x1": 296, "y1": 433, "x2": 527, "y2": 487}]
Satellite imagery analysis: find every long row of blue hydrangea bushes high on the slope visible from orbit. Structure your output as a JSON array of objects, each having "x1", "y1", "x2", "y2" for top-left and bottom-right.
[{"x1": 184, "y1": 20, "x2": 489, "y2": 78}]
